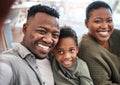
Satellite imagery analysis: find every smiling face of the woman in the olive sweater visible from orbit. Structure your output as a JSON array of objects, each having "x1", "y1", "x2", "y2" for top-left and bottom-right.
[{"x1": 85, "y1": 8, "x2": 114, "y2": 43}]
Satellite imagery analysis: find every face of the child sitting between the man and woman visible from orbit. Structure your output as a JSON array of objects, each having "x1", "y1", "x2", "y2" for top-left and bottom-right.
[{"x1": 53, "y1": 37, "x2": 78, "y2": 67}]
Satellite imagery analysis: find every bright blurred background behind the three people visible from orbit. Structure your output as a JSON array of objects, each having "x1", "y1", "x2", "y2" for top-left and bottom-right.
[{"x1": 0, "y1": 0, "x2": 120, "y2": 51}]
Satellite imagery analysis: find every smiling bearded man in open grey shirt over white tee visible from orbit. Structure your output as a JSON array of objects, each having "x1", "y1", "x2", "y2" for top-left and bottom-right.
[{"x1": 0, "y1": 5, "x2": 60, "y2": 85}]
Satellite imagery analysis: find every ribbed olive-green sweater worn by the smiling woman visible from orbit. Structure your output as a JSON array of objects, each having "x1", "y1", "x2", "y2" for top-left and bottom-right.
[{"x1": 78, "y1": 29, "x2": 120, "y2": 85}]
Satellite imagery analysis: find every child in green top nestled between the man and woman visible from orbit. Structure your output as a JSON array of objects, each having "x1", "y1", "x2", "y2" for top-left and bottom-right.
[{"x1": 51, "y1": 26, "x2": 93, "y2": 85}]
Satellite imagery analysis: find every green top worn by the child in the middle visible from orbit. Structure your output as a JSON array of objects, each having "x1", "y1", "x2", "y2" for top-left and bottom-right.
[{"x1": 52, "y1": 57, "x2": 93, "y2": 85}]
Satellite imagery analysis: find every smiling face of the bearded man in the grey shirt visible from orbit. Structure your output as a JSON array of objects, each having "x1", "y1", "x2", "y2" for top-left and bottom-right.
[{"x1": 22, "y1": 13, "x2": 60, "y2": 58}]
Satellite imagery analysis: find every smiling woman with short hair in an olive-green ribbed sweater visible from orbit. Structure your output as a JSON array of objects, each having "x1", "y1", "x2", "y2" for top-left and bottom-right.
[{"x1": 78, "y1": 1, "x2": 120, "y2": 85}]
